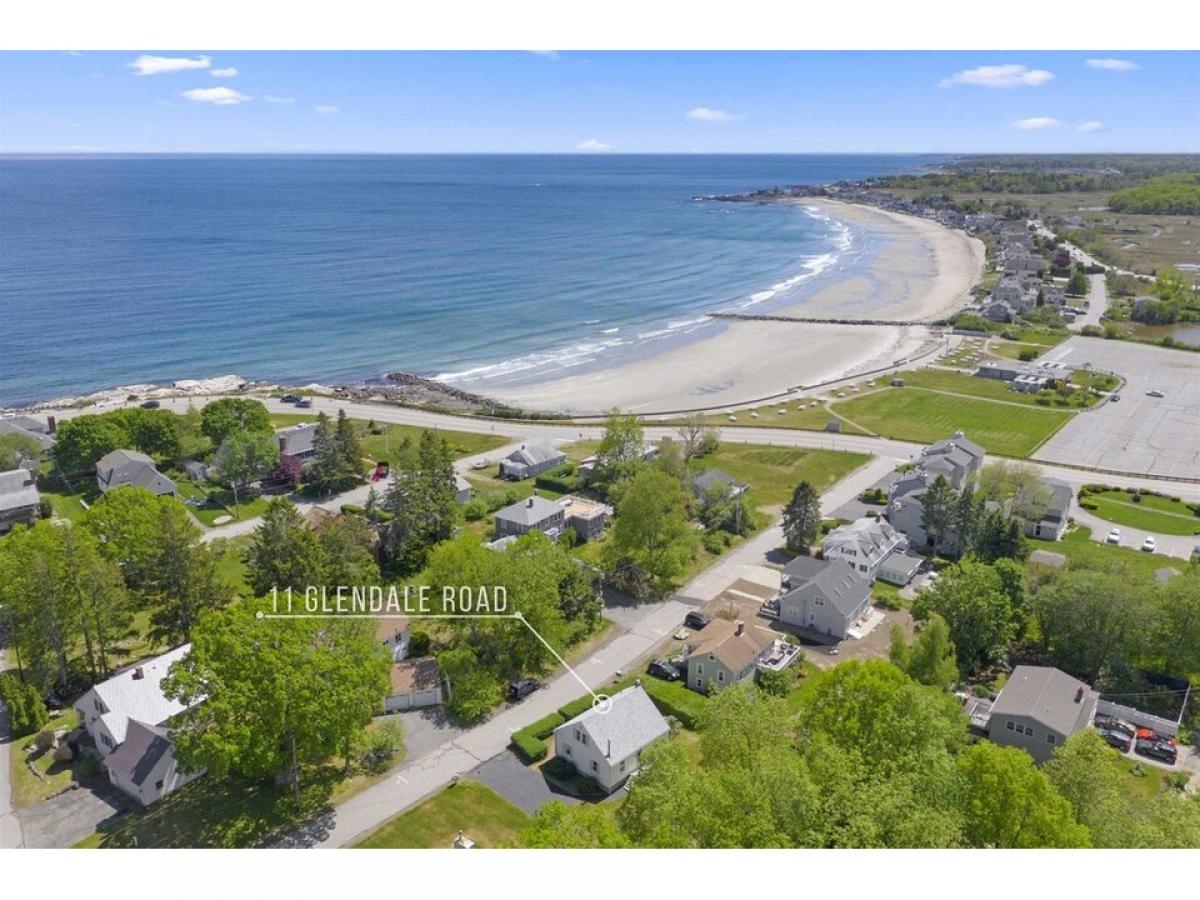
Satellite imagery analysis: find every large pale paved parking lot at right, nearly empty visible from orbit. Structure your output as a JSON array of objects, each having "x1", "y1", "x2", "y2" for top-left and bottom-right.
[{"x1": 1033, "y1": 337, "x2": 1200, "y2": 478}]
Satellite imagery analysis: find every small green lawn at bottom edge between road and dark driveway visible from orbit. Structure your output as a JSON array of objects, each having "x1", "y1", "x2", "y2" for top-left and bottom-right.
[{"x1": 354, "y1": 781, "x2": 528, "y2": 850}]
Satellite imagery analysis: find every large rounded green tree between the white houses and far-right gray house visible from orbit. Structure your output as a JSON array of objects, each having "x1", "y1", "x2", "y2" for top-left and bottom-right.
[{"x1": 912, "y1": 559, "x2": 1018, "y2": 674}]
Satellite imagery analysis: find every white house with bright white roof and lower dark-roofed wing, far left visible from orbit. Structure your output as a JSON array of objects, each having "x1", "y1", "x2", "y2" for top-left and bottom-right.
[{"x1": 74, "y1": 644, "x2": 202, "y2": 804}]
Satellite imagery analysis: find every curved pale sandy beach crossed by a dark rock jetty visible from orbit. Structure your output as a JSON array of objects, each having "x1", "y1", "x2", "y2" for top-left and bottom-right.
[{"x1": 482, "y1": 198, "x2": 984, "y2": 415}]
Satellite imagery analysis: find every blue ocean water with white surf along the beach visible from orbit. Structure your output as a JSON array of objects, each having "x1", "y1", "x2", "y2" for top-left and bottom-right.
[{"x1": 0, "y1": 156, "x2": 944, "y2": 406}]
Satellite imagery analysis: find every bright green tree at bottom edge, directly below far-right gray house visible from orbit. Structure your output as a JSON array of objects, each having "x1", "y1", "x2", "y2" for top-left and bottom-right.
[{"x1": 958, "y1": 740, "x2": 1091, "y2": 848}]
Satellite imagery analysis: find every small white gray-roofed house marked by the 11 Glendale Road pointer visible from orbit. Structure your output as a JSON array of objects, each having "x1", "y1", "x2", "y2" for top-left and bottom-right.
[{"x1": 554, "y1": 684, "x2": 671, "y2": 793}]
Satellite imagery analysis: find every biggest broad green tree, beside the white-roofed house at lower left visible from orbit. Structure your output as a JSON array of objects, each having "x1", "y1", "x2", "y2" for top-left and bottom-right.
[{"x1": 163, "y1": 601, "x2": 389, "y2": 798}]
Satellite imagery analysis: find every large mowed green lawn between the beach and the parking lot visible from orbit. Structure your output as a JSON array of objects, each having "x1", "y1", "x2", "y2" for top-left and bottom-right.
[{"x1": 835, "y1": 388, "x2": 1073, "y2": 457}]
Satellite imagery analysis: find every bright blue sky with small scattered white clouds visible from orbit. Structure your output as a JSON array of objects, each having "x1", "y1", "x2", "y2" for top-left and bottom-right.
[{"x1": 0, "y1": 49, "x2": 1200, "y2": 152}]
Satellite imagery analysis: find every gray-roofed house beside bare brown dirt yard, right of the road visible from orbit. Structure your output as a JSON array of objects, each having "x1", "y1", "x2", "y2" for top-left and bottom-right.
[{"x1": 779, "y1": 557, "x2": 871, "y2": 641}]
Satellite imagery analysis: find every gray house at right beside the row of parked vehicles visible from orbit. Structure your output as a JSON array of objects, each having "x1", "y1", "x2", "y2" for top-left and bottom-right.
[{"x1": 988, "y1": 666, "x2": 1099, "y2": 763}]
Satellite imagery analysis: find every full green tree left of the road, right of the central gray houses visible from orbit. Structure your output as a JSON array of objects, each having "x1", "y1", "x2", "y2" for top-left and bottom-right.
[{"x1": 604, "y1": 468, "x2": 696, "y2": 593}]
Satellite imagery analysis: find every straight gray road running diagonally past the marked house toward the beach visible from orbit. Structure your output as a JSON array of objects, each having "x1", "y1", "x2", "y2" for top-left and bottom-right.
[{"x1": 276, "y1": 457, "x2": 901, "y2": 847}]
